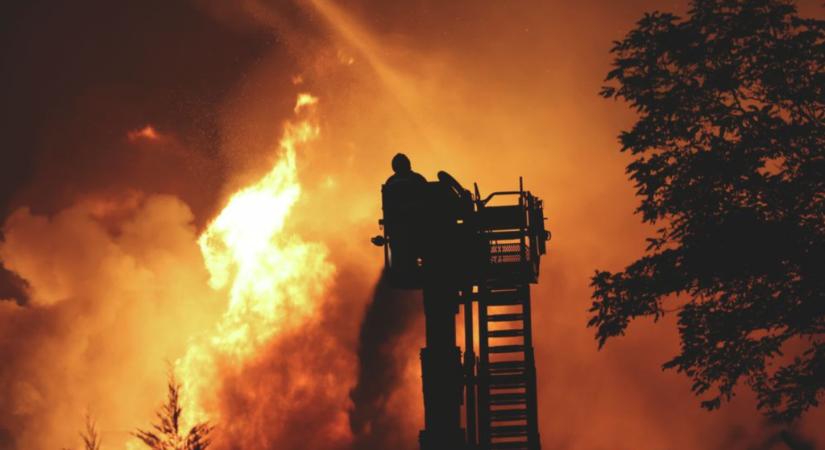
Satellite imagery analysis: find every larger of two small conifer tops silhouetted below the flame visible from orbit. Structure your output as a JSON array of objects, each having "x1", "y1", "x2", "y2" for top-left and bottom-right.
[{"x1": 135, "y1": 373, "x2": 213, "y2": 450}]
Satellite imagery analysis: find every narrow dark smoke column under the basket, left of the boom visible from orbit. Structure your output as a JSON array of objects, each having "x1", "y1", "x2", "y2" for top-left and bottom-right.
[{"x1": 349, "y1": 272, "x2": 423, "y2": 450}]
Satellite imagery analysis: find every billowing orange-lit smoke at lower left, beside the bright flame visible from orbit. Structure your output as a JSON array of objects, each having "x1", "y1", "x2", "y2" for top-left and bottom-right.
[{"x1": 0, "y1": 196, "x2": 220, "y2": 449}]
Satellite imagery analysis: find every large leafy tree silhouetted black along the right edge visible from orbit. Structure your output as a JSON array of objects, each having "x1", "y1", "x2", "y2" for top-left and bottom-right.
[{"x1": 589, "y1": 0, "x2": 825, "y2": 419}]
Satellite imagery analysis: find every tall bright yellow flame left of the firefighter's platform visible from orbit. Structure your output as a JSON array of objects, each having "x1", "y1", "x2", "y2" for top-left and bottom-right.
[{"x1": 176, "y1": 94, "x2": 334, "y2": 430}]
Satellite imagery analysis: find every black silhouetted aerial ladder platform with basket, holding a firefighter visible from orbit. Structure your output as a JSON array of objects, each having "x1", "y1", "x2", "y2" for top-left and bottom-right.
[{"x1": 372, "y1": 172, "x2": 550, "y2": 450}]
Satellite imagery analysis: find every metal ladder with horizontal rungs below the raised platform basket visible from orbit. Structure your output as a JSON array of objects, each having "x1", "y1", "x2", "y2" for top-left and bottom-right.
[{"x1": 477, "y1": 283, "x2": 541, "y2": 450}]
